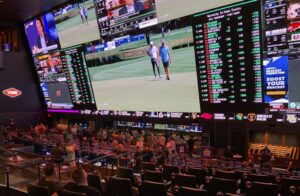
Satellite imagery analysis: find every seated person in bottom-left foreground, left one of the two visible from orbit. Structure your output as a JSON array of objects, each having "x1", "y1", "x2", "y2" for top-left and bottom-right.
[{"x1": 37, "y1": 165, "x2": 63, "y2": 195}]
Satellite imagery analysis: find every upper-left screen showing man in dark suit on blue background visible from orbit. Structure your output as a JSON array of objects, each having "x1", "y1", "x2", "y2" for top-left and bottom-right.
[{"x1": 24, "y1": 13, "x2": 60, "y2": 55}]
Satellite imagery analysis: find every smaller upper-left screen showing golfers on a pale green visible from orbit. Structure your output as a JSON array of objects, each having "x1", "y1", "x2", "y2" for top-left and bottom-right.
[{"x1": 54, "y1": 0, "x2": 100, "y2": 48}]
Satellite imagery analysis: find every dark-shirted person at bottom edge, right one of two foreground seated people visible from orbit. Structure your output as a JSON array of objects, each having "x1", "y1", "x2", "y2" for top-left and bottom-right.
[{"x1": 64, "y1": 168, "x2": 103, "y2": 196}]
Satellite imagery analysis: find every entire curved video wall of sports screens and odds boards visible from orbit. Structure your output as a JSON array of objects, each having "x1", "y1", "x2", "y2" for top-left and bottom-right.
[{"x1": 24, "y1": 0, "x2": 300, "y2": 121}]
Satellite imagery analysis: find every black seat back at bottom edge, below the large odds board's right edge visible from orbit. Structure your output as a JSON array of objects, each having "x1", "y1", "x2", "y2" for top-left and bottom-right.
[{"x1": 252, "y1": 182, "x2": 278, "y2": 196}]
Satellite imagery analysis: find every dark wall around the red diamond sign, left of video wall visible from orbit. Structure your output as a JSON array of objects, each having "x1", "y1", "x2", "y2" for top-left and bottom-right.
[{"x1": 0, "y1": 23, "x2": 45, "y2": 125}]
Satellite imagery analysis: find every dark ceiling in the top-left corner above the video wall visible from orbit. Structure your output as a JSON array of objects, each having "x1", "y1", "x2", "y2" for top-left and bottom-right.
[{"x1": 0, "y1": 0, "x2": 68, "y2": 23}]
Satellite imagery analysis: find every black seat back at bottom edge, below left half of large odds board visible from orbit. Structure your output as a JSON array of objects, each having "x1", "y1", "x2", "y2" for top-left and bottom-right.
[{"x1": 211, "y1": 178, "x2": 236, "y2": 195}]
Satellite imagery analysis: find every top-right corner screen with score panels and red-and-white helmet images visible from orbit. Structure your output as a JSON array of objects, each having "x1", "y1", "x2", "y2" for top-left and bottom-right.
[{"x1": 263, "y1": 0, "x2": 300, "y2": 57}]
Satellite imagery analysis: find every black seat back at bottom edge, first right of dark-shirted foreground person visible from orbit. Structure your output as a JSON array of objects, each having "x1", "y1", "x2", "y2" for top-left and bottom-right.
[{"x1": 107, "y1": 177, "x2": 132, "y2": 196}]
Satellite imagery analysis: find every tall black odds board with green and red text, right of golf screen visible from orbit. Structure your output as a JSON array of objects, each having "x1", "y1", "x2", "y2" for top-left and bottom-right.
[{"x1": 194, "y1": 0, "x2": 265, "y2": 113}]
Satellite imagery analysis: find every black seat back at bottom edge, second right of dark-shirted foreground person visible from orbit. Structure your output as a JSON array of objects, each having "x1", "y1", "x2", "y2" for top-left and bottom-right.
[{"x1": 140, "y1": 180, "x2": 168, "y2": 196}]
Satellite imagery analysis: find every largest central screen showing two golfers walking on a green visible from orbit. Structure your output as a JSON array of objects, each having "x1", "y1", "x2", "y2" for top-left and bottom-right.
[{"x1": 86, "y1": 17, "x2": 200, "y2": 113}]
